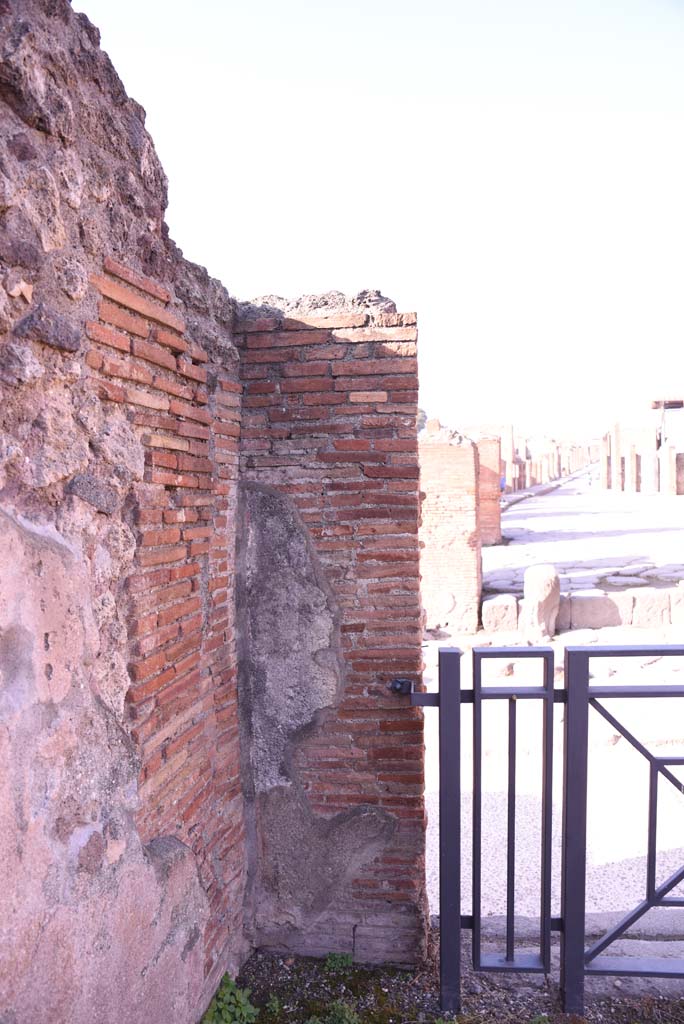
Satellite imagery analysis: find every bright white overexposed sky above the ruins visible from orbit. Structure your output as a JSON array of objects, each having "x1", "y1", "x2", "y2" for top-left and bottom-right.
[{"x1": 74, "y1": 0, "x2": 684, "y2": 433}]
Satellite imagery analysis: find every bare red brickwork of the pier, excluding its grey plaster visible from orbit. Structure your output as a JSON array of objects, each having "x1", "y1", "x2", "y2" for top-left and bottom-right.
[{"x1": 238, "y1": 309, "x2": 425, "y2": 963}]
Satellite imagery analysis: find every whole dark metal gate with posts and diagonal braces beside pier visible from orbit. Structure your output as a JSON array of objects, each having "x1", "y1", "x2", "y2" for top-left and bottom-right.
[{"x1": 411, "y1": 646, "x2": 684, "y2": 1014}]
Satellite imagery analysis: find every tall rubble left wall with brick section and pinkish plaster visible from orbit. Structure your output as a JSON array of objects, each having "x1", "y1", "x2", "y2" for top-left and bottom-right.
[{"x1": 0, "y1": 0, "x2": 247, "y2": 1024}]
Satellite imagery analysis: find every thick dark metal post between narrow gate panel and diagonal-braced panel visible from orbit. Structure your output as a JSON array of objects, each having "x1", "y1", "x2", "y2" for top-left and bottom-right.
[{"x1": 560, "y1": 647, "x2": 589, "y2": 1015}]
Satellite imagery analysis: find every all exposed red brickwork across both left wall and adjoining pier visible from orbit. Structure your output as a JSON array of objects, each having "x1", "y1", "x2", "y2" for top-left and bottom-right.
[{"x1": 86, "y1": 268, "x2": 425, "y2": 975}]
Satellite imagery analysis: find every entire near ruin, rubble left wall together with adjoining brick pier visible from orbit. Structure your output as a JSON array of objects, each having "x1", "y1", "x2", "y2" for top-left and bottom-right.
[{"x1": 0, "y1": 0, "x2": 424, "y2": 1024}]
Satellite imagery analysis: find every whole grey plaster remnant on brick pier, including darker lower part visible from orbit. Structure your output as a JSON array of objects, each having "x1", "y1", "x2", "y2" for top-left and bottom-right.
[{"x1": 238, "y1": 482, "x2": 397, "y2": 951}]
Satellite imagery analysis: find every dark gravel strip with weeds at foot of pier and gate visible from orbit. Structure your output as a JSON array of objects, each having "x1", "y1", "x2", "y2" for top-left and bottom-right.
[{"x1": 238, "y1": 933, "x2": 684, "y2": 1024}]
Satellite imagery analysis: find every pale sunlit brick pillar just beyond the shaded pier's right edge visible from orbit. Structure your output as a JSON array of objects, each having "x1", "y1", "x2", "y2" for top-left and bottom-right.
[{"x1": 420, "y1": 431, "x2": 482, "y2": 633}]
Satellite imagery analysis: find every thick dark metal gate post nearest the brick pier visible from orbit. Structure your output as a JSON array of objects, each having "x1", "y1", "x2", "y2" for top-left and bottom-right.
[{"x1": 439, "y1": 647, "x2": 461, "y2": 1013}]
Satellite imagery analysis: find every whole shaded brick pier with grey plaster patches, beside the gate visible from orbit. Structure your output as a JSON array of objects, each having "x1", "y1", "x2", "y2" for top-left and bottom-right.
[{"x1": 237, "y1": 304, "x2": 425, "y2": 964}]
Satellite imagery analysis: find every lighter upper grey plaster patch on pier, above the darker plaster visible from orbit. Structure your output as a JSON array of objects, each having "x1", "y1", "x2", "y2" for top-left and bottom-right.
[{"x1": 238, "y1": 483, "x2": 344, "y2": 793}]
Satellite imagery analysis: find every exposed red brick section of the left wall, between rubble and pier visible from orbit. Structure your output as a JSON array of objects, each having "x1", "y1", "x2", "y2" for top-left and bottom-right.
[{"x1": 82, "y1": 259, "x2": 244, "y2": 990}]
